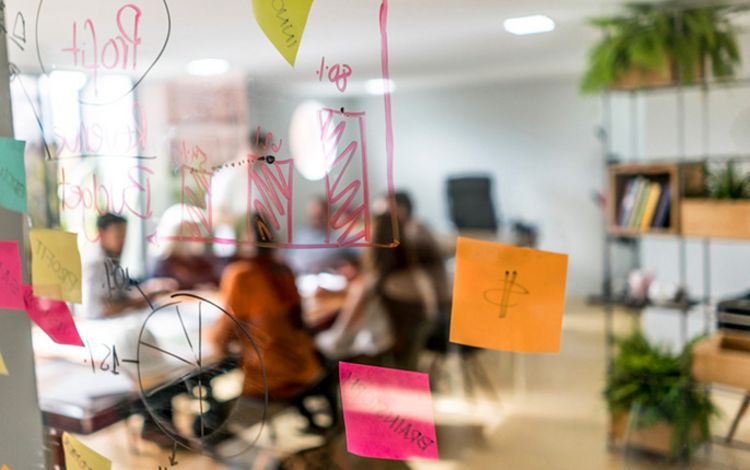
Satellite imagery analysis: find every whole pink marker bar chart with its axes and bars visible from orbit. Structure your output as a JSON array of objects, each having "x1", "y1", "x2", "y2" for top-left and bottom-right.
[{"x1": 142, "y1": 0, "x2": 399, "y2": 249}]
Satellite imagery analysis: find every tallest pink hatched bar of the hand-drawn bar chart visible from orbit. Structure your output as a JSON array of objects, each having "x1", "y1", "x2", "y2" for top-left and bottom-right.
[{"x1": 318, "y1": 108, "x2": 370, "y2": 246}]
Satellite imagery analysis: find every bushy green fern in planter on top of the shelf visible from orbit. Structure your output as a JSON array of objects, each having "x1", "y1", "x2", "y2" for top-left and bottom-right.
[{"x1": 581, "y1": 1, "x2": 743, "y2": 93}]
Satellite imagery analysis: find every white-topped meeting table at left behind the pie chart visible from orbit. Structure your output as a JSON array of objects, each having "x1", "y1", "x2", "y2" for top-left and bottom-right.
[{"x1": 32, "y1": 292, "x2": 229, "y2": 463}]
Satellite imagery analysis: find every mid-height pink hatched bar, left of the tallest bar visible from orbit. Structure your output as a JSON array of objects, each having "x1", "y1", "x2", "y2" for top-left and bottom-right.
[{"x1": 247, "y1": 160, "x2": 294, "y2": 243}]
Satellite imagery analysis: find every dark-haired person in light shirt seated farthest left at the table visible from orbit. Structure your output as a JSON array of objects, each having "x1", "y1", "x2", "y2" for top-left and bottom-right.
[{"x1": 76, "y1": 213, "x2": 175, "y2": 318}]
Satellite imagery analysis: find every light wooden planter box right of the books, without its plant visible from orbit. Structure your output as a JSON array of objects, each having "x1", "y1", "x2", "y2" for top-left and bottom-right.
[{"x1": 680, "y1": 199, "x2": 750, "y2": 239}]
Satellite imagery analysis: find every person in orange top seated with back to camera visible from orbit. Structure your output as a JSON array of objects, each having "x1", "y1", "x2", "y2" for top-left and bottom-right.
[{"x1": 212, "y1": 216, "x2": 334, "y2": 428}]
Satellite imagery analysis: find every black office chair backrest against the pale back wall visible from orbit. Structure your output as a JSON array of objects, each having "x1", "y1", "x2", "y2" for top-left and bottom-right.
[{"x1": 447, "y1": 176, "x2": 498, "y2": 231}]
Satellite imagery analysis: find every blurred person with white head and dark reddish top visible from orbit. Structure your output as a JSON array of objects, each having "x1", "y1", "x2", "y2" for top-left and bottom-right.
[{"x1": 153, "y1": 204, "x2": 219, "y2": 290}]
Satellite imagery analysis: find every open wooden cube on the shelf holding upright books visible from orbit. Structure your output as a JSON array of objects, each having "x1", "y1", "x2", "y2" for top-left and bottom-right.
[{"x1": 607, "y1": 162, "x2": 703, "y2": 236}]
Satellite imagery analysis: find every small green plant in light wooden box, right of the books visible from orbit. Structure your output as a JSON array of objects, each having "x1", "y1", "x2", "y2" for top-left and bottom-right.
[{"x1": 680, "y1": 160, "x2": 750, "y2": 238}]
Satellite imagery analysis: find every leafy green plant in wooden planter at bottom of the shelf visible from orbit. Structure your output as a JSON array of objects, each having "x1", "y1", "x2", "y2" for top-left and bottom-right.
[{"x1": 604, "y1": 332, "x2": 717, "y2": 457}]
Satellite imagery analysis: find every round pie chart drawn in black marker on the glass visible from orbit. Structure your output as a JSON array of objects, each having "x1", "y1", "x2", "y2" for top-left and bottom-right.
[{"x1": 134, "y1": 292, "x2": 268, "y2": 458}]
